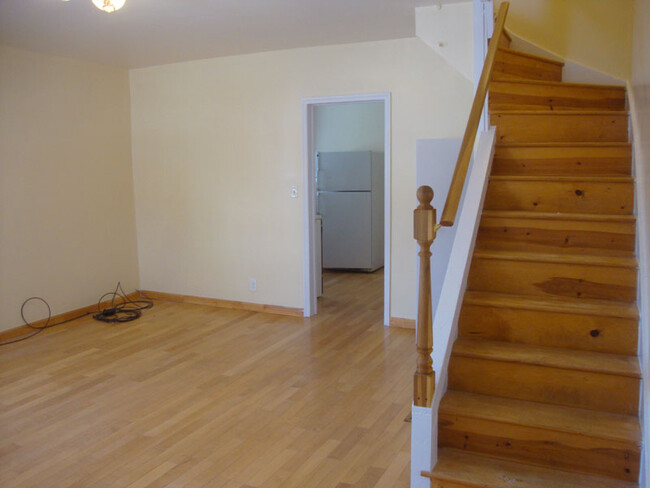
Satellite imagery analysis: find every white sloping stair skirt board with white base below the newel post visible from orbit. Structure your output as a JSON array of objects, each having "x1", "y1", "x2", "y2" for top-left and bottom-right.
[{"x1": 411, "y1": 127, "x2": 496, "y2": 488}]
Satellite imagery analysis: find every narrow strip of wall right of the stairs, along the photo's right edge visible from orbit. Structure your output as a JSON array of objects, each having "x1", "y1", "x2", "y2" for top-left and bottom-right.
[{"x1": 631, "y1": 0, "x2": 650, "y2": 487}]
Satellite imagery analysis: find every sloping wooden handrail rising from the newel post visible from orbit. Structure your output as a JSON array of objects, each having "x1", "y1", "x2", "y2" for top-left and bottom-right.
[{"x1": 440, "y1": 2, "x2": 510, "y2": 227}]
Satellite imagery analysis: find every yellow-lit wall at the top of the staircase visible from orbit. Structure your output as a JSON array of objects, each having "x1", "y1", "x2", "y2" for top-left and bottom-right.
[{"x1": 497, "y1": 0, "x2": 634, "y2": 80}]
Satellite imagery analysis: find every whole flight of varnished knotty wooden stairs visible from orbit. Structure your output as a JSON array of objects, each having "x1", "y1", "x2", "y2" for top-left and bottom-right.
[{"x1": 427, "y1": 41, "x2": 641, "y2": 488}]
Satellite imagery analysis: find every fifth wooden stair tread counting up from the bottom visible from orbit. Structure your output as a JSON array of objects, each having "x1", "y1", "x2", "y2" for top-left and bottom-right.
[{"x1": 474, "y1": 249, "x2": 638, "y2": 269}]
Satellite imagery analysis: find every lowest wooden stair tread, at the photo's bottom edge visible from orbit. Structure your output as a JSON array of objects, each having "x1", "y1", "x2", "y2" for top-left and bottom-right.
[{"x1": 422, "y1": 448, "x2": 638, "y2": 488}]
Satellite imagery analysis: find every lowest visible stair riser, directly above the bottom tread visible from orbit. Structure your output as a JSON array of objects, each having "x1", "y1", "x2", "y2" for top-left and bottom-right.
[{"x1": 438, "y1": 413, "x2": 640, "y2": 481}]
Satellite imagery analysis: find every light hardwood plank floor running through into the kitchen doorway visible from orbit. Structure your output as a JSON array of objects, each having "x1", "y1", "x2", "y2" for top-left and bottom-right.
[{"x1": 0, "y1": 272, "x2": 414, "y2": 488}]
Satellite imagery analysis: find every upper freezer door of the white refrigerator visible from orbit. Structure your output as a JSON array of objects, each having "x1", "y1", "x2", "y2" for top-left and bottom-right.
[{"x1": 316, "y1": 151, "x2": 372, "y2": 191}]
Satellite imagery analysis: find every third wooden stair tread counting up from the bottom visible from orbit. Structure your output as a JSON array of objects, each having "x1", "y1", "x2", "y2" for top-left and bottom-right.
[{"x1": 452, "y1": 338, "x2": 641, "y2": 378}]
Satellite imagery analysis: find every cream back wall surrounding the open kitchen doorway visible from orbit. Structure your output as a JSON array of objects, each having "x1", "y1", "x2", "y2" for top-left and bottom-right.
[{"x1": 131, "y1": 39, "x2": 473, "y2": 318}]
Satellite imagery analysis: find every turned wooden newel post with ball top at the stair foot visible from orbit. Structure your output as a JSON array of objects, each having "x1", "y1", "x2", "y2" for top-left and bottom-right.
[{"x1": 413, "y1": 186, "x2": 439, "y2": 407}]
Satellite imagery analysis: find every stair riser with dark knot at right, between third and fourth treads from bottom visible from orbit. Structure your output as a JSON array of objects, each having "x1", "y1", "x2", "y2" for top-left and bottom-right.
[{"x1": 458, "y1": 304, "x2": 638, "y2": 355}]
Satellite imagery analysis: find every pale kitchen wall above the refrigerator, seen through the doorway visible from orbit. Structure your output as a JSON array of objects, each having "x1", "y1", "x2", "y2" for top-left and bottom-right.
[{"x1": 314, "y1": 102, "x2": 384, "y2": 152}]
